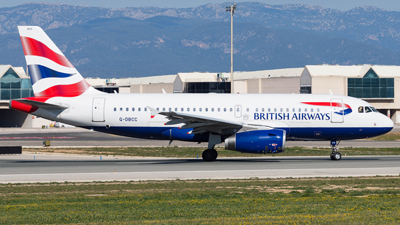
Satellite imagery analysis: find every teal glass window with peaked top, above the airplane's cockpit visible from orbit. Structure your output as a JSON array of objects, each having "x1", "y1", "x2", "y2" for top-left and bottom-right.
[{"x1": 347, "y1": 69, "x2": 394, "y2": 98}]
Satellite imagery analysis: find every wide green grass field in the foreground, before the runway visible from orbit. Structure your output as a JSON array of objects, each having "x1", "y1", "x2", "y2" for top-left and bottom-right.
[{"x1": 0, "y1": 177, "x2": 400, "y2": 224}]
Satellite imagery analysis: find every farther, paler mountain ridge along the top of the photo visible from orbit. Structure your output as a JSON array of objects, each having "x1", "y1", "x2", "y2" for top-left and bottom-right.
[{"x1": 0, "y1": 2, "x2": 400, "y2": 51}]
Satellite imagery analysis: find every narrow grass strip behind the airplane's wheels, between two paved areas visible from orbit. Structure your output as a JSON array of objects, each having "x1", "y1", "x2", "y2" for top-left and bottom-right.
[{"x1": 23, "y1": 146, "x2": 400, "y2": 158}]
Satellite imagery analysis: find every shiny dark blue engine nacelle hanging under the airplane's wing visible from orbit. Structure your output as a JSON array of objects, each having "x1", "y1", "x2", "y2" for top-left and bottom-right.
[{"x1": 225, "y1": 130, "x2": 286, "y2": 154}]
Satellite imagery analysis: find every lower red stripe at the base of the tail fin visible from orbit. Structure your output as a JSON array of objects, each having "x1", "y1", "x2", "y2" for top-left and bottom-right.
[{"x1": 35, "y1": 80, "x2": 90, "y2": 97}]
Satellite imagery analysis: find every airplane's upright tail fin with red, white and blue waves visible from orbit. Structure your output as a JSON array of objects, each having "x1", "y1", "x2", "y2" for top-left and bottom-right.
[{"x1": 18, "y1": 26, "x2": 95, "y2": 97}]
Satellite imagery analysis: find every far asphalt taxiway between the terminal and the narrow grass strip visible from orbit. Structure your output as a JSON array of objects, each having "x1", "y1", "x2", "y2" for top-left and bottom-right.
[{"x1": 0, "y1": 126, "x2": 400, "y2": 149}]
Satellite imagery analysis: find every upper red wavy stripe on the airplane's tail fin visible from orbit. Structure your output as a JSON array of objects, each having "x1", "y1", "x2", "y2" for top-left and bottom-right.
[{"x1": 21, "y1": 37, "x2": 74, "y2": 68}]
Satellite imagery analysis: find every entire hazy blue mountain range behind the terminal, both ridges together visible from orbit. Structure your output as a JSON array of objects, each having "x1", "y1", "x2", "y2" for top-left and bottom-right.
[{"x1": 0, "y1": 3, "x2": 400, "y2": 78}]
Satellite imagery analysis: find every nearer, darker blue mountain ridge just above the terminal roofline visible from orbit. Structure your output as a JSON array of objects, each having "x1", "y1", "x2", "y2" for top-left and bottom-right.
[{"x1": 0, "y1": 16, "x2": 400, "y2": 78}]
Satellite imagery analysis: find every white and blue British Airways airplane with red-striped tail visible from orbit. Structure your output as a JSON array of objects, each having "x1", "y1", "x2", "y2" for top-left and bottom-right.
[{"x1": 9, "y1": 26, "x2": 393, "y2": 161}]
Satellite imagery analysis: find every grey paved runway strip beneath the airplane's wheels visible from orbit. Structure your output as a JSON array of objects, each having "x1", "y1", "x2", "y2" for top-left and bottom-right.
[{"x1": 0, "y1": 154, "x2": 400, "y2": 183}]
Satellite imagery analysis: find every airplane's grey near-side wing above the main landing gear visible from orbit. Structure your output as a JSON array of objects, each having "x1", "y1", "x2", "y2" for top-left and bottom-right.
[{"x1": 147, "y1": 106, "x2": 243, "y2": 135}]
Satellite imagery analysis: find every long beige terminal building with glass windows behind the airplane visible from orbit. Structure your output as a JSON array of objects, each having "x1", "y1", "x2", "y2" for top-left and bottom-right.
[{"x1": 0, "y1": 64, "x2": 400, "y2": 128}]
